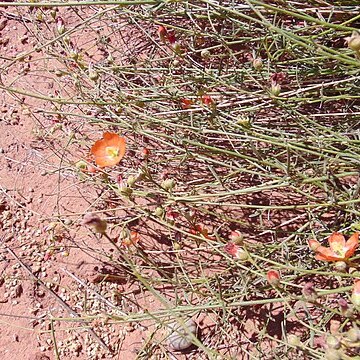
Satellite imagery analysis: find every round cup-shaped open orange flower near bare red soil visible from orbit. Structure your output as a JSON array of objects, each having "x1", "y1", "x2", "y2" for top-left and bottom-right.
[{"x1": 91, "y1": 132, "x2": 126, "y2": 167}]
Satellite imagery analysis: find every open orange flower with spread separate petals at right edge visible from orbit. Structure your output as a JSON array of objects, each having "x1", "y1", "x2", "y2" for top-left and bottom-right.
[{"x1": 309, "y1": 232, "x2": 359, "y2": 261}]
